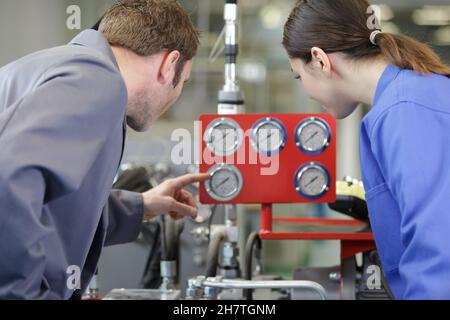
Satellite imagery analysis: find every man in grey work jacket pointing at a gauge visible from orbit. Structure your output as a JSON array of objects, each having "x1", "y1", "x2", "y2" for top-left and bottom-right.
[{"x1": 0, "y1": 0, "x2": 208, "y2": 299}]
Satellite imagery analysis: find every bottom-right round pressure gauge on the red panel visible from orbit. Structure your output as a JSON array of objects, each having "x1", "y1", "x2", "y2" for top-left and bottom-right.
[{"x1": 295, "y1": 162, "x2": 330, "y2": 199}]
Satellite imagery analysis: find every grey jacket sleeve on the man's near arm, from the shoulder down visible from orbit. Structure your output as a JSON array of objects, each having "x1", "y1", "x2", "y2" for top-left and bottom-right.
[{"x1": 0, "y1": 55, "x2": 127, "y2": 299}]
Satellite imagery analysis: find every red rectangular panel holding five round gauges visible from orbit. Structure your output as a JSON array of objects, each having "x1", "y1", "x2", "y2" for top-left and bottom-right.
[{"x1": 199, "y1": 114, "x2": 336, "y2": 204}]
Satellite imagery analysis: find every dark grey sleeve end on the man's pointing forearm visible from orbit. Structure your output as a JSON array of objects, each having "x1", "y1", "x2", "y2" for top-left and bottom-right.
[{"x1": 105, "y1": 190, "x2": 144, "y2": 246}]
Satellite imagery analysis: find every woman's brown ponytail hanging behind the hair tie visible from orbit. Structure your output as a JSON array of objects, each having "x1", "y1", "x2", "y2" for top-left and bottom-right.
[{"x1": 376, "y1": 33, "x2": 450, "y2": 77}]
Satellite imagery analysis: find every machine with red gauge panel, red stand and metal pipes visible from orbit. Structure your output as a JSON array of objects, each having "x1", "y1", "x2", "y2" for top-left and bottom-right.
[{"x1": 186, "y1": 0, "x2": 387, "y2": 299}]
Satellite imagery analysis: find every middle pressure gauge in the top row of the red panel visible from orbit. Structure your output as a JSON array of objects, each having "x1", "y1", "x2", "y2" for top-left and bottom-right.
[{"x1": 250, "y1": 118, "x2": 287, "y2": 156}]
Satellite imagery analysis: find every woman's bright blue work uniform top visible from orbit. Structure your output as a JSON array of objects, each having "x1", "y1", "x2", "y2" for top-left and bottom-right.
[{"x1": 361, "y1": 65, "x2": 450, "y2": 299}]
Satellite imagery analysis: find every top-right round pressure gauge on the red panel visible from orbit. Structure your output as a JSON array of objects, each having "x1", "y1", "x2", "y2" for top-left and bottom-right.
[{"x1": 295, "y1": 117, "x2": 331, "y2": 155}]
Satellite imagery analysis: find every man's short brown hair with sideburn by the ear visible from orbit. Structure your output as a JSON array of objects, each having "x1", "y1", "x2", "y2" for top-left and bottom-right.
[{"x1": 99, "y1": 0, "x2": 200, "y2": 87}]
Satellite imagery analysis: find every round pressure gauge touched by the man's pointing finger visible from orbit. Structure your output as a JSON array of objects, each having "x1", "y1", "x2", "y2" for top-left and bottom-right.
[{"x1": 205, "y1": 164, "x2": 243, "y2": 201}]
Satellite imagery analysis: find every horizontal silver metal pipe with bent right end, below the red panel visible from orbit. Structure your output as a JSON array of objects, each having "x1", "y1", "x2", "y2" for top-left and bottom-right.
[{"x1": 202, "y1": 279, "x2": 327, "y2": 300}]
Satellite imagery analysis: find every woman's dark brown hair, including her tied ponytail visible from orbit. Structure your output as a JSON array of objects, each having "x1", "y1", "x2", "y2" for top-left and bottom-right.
[{"x1": 283, "y1": 0, "x2": 450, "y2": 77}]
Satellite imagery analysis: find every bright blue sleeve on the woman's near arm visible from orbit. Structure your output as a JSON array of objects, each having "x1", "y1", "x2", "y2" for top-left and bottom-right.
[{"x1": 371, "y1": 103, "x2": 450, "y2": 299}]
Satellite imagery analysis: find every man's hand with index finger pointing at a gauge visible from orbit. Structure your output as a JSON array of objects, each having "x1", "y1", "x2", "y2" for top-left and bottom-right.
[{"x1": 143, "y1": 173, "x2": 210, "y2": 220}]
